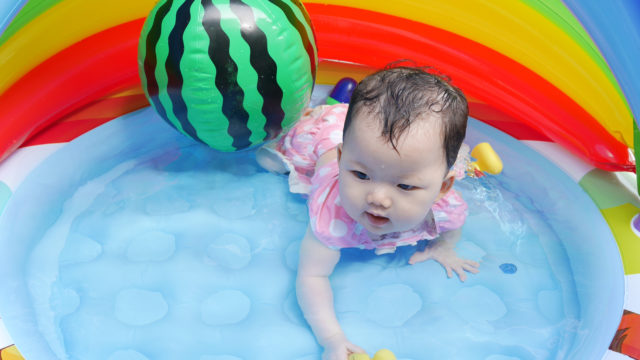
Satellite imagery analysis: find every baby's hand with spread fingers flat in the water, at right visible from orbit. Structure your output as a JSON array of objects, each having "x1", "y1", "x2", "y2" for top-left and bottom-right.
[{"x1": 409, "y1": 242, "x2": 480, "y2": 281}]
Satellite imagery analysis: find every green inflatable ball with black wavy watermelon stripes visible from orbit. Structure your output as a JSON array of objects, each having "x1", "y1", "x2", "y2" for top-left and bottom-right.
[{"x1": 138, "y1": 0, "x2": 318, "y2": 151}]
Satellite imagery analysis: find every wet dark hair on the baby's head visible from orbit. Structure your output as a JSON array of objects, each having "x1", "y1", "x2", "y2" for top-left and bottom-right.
[{"x1": 343, "y1": 63, "x2": 469, "y2": 169}]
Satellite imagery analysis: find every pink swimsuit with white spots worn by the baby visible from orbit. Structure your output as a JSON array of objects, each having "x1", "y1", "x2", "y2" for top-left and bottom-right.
[{"x1": 268, "y1": 104, "x2": 468, "y2": 254}]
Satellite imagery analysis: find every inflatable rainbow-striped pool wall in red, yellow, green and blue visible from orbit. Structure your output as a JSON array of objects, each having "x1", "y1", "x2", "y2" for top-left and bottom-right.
[{"x1": 0, "y1": 0, "x2": 640, "y2": 360}]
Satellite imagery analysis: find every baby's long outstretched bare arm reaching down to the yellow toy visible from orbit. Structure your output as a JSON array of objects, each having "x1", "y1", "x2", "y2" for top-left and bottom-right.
[{"x1": 296, "y1": 228, "x2": 365, "y2": 360}]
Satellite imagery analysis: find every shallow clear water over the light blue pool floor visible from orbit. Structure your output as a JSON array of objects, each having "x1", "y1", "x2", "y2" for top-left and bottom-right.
[{"x1": 0, "y1": 109, "x2": 620, "y2": 360}]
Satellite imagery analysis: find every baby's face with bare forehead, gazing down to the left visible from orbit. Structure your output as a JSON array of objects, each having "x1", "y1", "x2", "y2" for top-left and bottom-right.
[{"x1": 339, "y1": 113, "x2": 453, "y2": 235}]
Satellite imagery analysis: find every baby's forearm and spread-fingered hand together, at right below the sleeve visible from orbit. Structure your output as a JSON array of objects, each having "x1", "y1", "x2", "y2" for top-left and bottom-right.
[{"x1": 409, "y1": 229, "x2": 480, "y2": 281}]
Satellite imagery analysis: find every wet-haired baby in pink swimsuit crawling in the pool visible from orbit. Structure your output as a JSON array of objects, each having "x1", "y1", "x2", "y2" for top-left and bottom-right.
[{"x1": 257, "y1": 67, "x2": 479, "y2": 360}]
